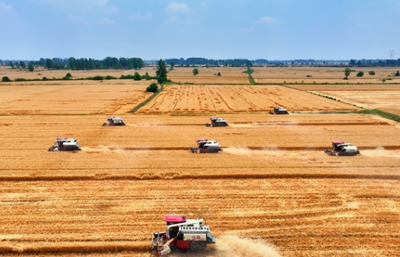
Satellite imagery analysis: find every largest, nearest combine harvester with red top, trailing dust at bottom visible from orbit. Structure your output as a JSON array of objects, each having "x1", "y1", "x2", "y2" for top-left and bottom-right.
[{"x1": 150, "y1": 216, "x2": 216, "y2": 256}]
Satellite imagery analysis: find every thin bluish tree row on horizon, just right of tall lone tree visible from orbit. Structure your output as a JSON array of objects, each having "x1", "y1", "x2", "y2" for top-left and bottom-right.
[{"x1": 165, "y1": 57, "x2": 252, "y2": 67}]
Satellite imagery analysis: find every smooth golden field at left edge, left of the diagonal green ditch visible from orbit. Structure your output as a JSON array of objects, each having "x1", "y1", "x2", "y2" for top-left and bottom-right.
[{"x1": 0, "y1": 80, "x2": 151, "y2": 115}]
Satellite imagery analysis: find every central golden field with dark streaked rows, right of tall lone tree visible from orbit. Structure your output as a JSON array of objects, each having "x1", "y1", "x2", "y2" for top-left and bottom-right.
[{"x1": 139, "y1": 85, "x2": 358, "y2": 114}]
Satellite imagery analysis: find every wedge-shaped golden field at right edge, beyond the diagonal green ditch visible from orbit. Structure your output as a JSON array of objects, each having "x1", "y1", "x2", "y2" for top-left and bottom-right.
[{"x1": 291, "y1": 84, "x2": 400, "y2": 115}]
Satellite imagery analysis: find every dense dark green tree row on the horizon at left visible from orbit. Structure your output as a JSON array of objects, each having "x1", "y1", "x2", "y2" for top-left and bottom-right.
[{"x1": 26, "y1": 57, "x2": 144, "y2": 70}]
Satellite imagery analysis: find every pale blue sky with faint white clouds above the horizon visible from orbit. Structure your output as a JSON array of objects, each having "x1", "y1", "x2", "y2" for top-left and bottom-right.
[{"x1": 0, "y1": 0, "x2": 400, "y2": 60}]
